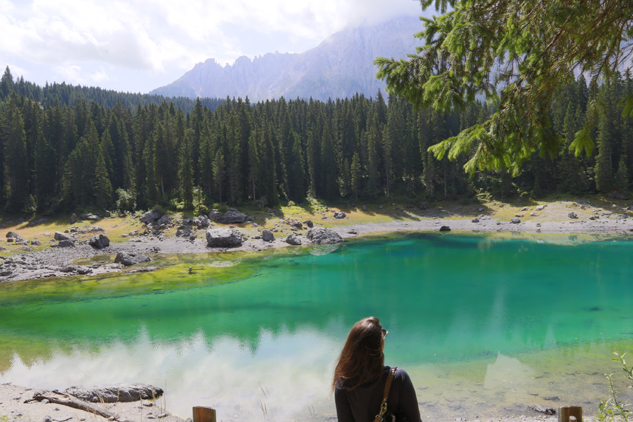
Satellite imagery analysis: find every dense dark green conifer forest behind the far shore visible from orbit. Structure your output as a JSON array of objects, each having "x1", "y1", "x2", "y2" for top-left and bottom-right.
[{"x1": 0, "y1": 67, "x2": 633, "y2": 213}]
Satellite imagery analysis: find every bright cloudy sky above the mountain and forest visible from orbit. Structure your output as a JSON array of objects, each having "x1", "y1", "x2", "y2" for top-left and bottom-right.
[{"x1": 0, "y1": 0, "x2": 422, "y2": 93}]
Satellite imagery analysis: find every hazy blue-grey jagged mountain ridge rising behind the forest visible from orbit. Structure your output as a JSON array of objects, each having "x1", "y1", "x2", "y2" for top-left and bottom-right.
[{"x1": 150, "y1": 17, "x2": 422, "y2": 102}]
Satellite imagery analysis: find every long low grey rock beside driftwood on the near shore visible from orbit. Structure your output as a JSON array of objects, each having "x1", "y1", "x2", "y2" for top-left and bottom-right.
[{"x1": 64, "y1": 384, "x2": 163, "y2": 403}]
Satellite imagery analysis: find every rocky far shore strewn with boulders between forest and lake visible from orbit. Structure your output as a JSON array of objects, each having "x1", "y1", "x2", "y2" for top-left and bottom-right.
[{"x1": 0, "y1": 202, "x2": 633, "y2": 282}]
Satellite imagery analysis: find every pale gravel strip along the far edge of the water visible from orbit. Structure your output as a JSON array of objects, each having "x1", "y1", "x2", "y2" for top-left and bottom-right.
[{"x1": 0, "y1": 215, "x2": 633, "y2": 283}]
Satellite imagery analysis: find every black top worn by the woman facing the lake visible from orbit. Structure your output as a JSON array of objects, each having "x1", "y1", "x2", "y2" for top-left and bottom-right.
[{"x1": 334, "y1": 366, "x2": 421, "y2": 422}]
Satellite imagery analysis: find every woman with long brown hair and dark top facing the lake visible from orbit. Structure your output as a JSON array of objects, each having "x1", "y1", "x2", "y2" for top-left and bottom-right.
[{"x1": 332, "y1": 317, "x2": 420, "y2": 422}]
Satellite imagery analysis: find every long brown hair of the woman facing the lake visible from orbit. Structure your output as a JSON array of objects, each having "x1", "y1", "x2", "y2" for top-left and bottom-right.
[{"x1": 332, "y1": 317, "x2": 385, "y2": 390}]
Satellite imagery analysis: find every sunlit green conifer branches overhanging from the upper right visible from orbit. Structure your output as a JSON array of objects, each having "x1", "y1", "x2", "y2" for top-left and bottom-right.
[{"x1": 376, "y1": 0, "x2": 633, "y2": 175}]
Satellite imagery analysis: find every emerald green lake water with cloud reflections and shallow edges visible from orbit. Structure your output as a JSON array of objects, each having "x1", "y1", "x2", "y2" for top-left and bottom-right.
[{"x1": 0, "y1": 234, "x2": 633, "y2": 421}]
